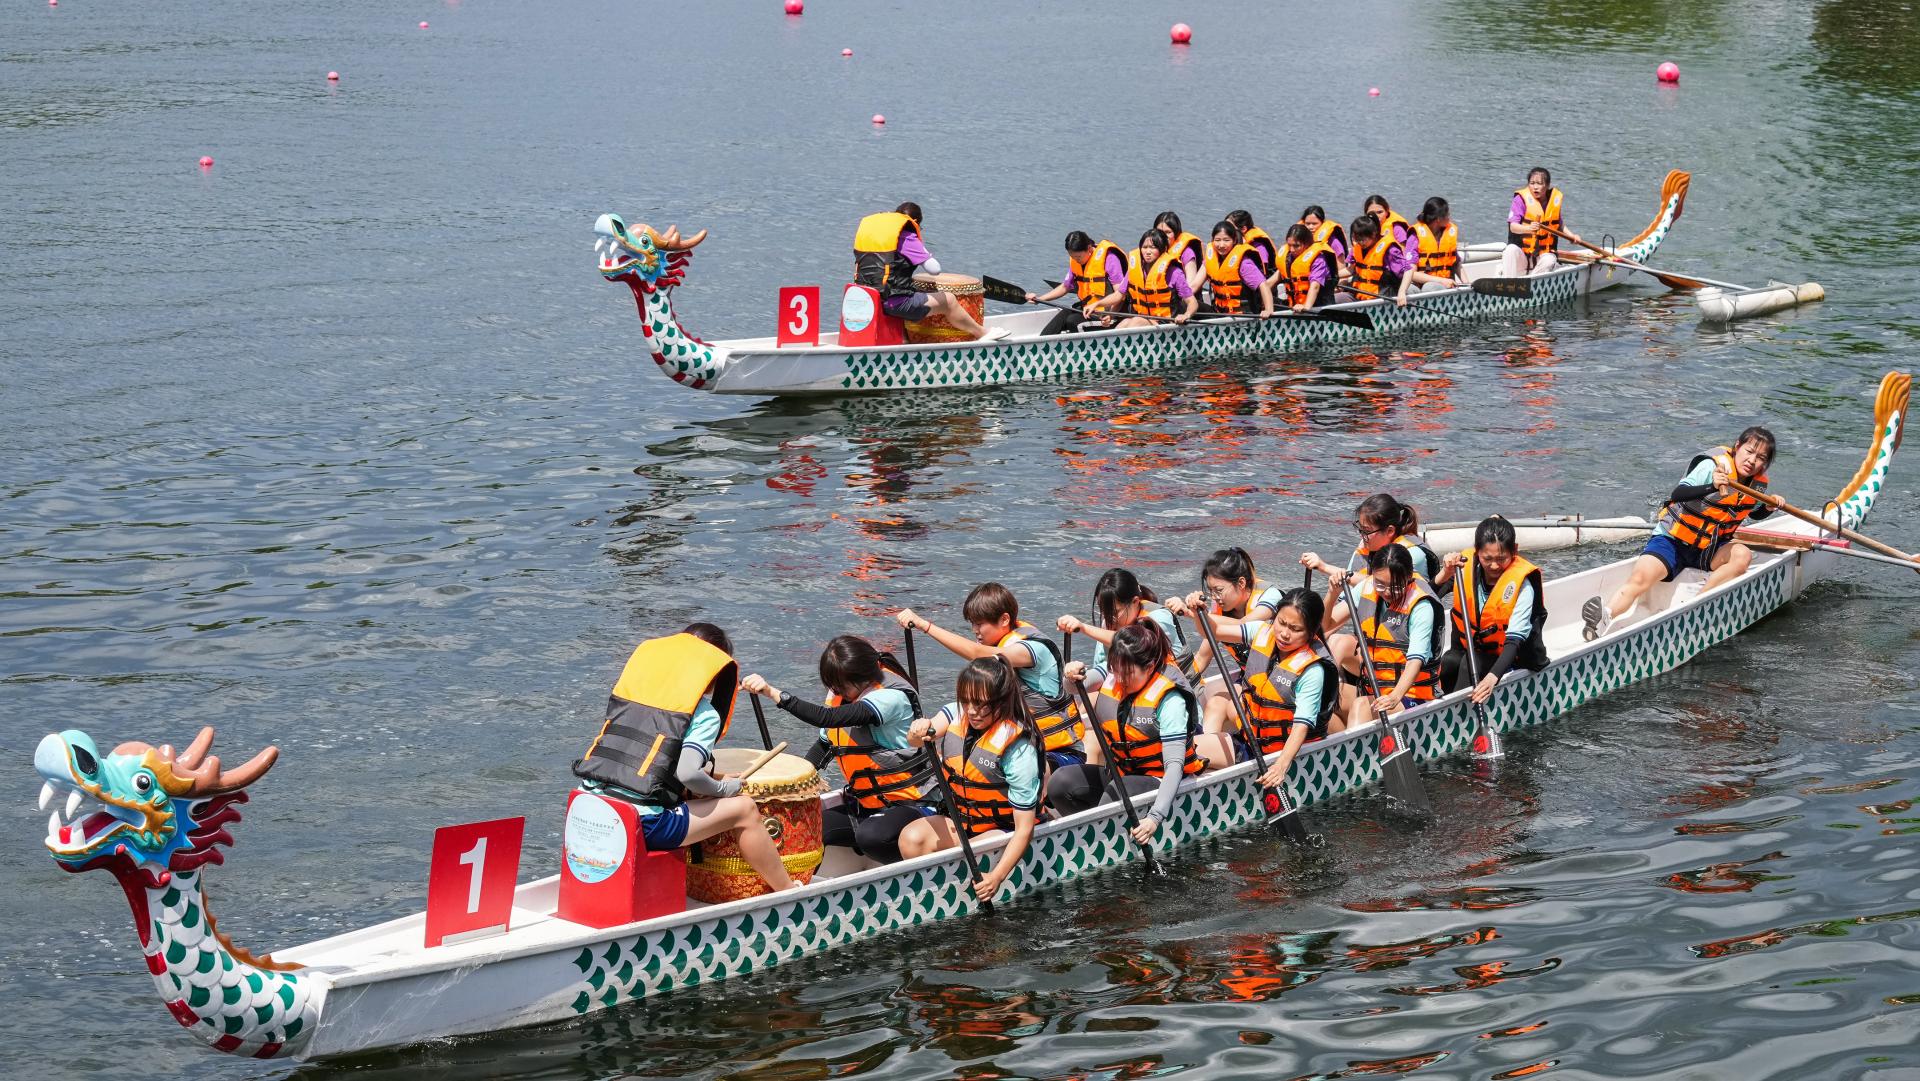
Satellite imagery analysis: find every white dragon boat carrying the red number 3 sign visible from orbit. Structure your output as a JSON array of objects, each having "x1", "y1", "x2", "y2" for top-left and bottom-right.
[{"x1": 593, "y1": 169, "x2": 1692, "y2": 396}]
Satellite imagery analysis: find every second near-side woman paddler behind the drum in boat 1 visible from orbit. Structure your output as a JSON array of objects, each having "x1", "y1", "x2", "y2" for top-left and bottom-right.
[{"x1": 1046, "y1": 620, "x2": 1208, "y2": 845}]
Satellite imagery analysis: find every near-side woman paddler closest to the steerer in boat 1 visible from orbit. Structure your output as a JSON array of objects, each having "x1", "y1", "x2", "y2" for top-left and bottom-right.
[{"x1": 1434, "y1": 515, "x2": 1548, "y2": 703}]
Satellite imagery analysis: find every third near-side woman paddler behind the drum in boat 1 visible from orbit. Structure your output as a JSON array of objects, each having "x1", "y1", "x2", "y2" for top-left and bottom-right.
[{"x1": 1200, "y1": 589, "x2": 1346, "y2": 785}]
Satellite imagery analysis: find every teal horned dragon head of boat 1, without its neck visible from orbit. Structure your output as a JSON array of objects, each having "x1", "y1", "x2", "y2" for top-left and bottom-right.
[{"x1": 33, "y1": 728, "x2": 280, "y2": 883}]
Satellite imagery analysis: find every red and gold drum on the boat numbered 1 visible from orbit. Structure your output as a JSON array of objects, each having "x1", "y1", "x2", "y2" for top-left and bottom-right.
[{"x1": 687, "y1": 747, "x2": 828, "y2": 904}]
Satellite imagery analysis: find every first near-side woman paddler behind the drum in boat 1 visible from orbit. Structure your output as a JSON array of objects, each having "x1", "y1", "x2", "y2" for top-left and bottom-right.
[{"x1": 900, "y1": 657, "x2": 1041, "y2": 901}]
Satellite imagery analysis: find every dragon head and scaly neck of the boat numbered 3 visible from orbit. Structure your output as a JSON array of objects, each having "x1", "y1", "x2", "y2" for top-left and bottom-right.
[{"x1": 593, "y1": 213, "x2": 726, "y2": 390}]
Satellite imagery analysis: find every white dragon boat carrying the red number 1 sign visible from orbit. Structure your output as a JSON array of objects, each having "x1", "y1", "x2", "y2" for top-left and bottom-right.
[{"x1": 35, "y1": 372, "x2": 1910, "y2": 1058}]
